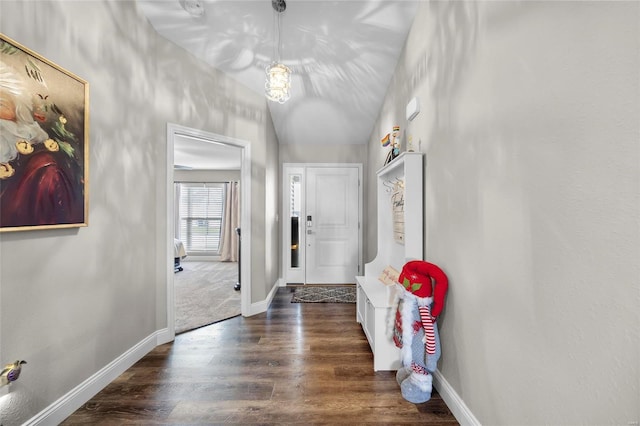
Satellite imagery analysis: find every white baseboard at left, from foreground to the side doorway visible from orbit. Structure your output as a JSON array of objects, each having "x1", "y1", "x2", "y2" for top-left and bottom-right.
[{"x1": 23, "y1": 330, "x2": 165, "y2": 426}]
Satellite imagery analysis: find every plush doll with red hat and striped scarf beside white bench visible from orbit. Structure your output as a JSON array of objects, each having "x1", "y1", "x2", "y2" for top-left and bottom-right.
[{"x1": 393, "y1": 260, "x2": 449, "y2": 404}]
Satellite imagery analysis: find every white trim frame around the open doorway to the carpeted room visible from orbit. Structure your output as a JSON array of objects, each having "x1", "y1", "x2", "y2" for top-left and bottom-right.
[{"x1": 165, "y1": 123, "x2": 251, "y2": 341}]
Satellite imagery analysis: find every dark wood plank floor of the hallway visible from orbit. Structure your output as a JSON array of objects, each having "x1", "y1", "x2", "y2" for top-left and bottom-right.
[{"x1": 62, "y1": 288, "x2": 458, "y2": 425}]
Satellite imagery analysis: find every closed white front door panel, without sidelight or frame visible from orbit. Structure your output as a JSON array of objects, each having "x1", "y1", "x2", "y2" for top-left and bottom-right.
[{"x1": 301, "y1": 167, "x2": 360, "y2": 284}]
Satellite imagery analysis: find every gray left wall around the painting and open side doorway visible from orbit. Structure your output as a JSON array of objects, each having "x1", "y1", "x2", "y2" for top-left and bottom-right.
[{"x1": 0, "y1": 0, "x2": 278, "y2": 426}]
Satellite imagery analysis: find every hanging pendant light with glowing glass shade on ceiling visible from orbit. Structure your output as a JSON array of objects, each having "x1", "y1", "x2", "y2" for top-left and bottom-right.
[{"x1": 264, "y1": 0, "x2": 291, "y2": 104}]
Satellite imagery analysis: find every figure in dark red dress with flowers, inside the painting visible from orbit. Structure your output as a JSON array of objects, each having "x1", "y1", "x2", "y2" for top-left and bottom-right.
[{"x1": 0, "y1": 62, "x2": 84, "y2": 228}]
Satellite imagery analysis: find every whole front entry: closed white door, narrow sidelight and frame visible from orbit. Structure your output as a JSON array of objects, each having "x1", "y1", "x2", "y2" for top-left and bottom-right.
[{"x1": 282, "y1": 163, "x2": 363, "y2": 284}]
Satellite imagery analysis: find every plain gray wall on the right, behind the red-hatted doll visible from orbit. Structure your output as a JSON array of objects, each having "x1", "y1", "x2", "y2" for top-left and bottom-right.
[{"x1": 367, "y1": 1, "x2": 640, "y2": 425}]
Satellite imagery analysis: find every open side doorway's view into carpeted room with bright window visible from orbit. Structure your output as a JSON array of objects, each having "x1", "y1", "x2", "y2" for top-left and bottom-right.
[{"x1": 173, "y1": 180, "x2": 241, "y2": 334}]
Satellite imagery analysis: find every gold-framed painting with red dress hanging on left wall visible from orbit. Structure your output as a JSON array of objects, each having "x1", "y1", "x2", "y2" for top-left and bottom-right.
[{"x1": 0, "y1": 34, "x2": 89, "y2": 232}]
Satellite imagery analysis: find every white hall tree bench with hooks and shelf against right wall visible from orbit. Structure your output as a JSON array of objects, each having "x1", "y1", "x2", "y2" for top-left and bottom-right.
[{"x1": 356, "y1": 152, "x2": 424, "y2": 371}]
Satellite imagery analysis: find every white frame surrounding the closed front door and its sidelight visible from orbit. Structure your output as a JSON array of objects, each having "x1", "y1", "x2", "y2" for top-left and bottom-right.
[{"x1": 282, "y1": 163, "x2": 364, "y2": 285}]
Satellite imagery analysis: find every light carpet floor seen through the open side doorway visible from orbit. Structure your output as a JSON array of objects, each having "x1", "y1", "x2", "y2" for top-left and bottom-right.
[{"x1": 173, "y1": 261, "x2": 240, "y2": 334}]
